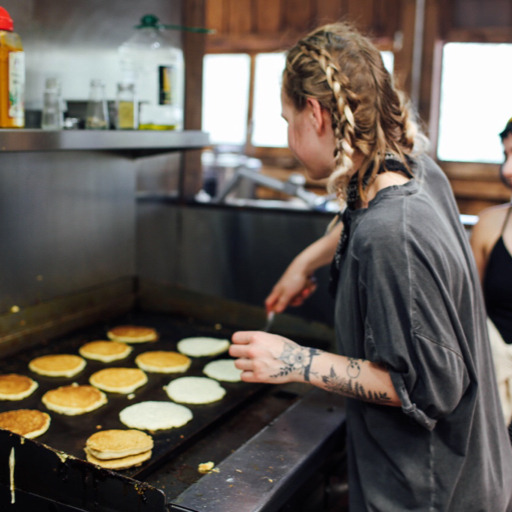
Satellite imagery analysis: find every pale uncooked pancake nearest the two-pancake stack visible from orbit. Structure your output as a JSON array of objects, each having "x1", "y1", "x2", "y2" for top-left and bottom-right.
[{"x1": 119, "y1": 401, "x2": 192, "y2": 431}]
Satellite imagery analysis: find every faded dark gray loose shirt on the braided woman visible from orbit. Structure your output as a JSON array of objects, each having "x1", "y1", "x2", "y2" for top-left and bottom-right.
[{"x1": 335, "y1": 156, "x2": 512, "y2": 512}]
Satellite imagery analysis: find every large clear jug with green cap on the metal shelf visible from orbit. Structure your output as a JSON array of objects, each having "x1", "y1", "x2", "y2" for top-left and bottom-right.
[{"x1": 118, "y1": 14, "x2": 185, "y2": 130}]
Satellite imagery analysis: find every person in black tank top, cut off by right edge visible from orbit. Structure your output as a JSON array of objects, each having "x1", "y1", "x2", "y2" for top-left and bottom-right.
[{"x1": 471, "y1": 118, "x2": 512, "y2": 442}]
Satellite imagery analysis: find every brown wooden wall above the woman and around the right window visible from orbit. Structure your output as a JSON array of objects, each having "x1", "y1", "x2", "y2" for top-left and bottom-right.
[{"x1": 200, "y1": 0, "x2": 512, "y2": 213}]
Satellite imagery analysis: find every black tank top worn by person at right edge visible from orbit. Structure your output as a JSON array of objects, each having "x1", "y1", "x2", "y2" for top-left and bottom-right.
[{"x1": 483, "y1": 205, "x2": 512, "y2": 343}]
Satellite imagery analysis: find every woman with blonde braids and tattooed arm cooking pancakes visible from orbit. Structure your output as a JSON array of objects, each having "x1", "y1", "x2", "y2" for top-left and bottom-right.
[{"x1": 230, "y1": 23, "x2": 512, "y2": 512}]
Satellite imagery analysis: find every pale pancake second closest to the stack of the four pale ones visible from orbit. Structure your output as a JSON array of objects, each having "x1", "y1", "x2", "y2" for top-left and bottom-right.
[{"x1": 164, "y1": 377, "x2": 226, "y2": 404}]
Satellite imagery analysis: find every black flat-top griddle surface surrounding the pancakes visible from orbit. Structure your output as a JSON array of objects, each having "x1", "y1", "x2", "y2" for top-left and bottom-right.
[{"x1": 0, "y1": 311, "x2": 265, "y2": 480}]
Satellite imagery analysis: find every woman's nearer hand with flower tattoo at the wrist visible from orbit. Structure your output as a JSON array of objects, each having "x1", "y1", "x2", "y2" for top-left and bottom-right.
[{"x1": 229, "y1": 331, "x2": 312, "y2": 384}]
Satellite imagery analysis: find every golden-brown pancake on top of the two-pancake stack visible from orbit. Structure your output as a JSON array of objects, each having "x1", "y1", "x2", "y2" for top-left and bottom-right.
[{"x1": 85, "y1": 429, "x2": 153, "y2": 460}]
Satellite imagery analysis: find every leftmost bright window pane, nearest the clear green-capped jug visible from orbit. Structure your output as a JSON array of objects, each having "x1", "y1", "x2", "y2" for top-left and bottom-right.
[{"x1": 202, "y1": 54, "x2": 251, "y2": 146}]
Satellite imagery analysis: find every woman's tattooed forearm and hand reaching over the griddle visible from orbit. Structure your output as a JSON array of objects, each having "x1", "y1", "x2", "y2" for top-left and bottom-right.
[{"x1": 229, "y1": 331, "x2": 400, "y2": 406}]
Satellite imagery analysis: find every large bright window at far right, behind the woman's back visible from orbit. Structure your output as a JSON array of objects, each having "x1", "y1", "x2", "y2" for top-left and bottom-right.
[{"x1": 437, "y1": 43, "x2": 512, "y2": 163}]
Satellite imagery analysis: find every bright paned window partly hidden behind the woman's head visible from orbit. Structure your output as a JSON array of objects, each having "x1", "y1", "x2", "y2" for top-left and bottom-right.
[{"x1": 202, "y1": 51, "x2": 393, "y2": 148}]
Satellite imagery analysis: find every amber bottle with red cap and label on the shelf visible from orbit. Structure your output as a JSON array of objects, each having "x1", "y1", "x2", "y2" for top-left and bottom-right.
[{"x1": 0, "y1": 7, "x2": 25, "y2": 128}]
